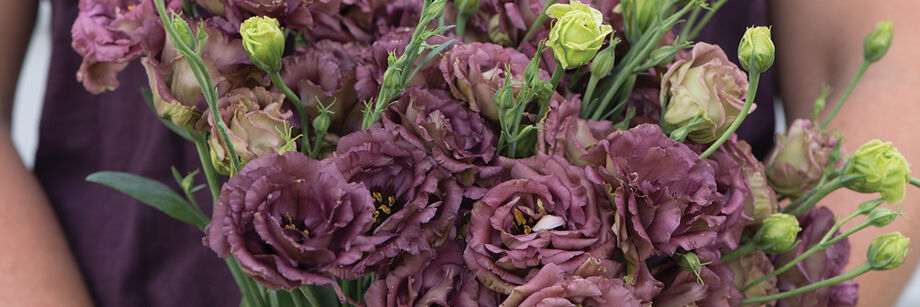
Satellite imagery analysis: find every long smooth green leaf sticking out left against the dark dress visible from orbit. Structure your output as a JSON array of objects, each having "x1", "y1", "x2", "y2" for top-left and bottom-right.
[{"x1": 86, "y1": 172, "x2": 208, "y2": 229}]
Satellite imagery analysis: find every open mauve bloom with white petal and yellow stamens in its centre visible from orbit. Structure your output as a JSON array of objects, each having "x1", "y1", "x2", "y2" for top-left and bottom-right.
[{"x1": 463, "y1": 154, "x2": 615, "y2": 293}]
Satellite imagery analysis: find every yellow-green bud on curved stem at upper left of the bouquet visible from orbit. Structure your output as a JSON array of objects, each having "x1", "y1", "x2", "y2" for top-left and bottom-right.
[{"x1": 240, "y1": 16, "x2": 284, "y2": 73}]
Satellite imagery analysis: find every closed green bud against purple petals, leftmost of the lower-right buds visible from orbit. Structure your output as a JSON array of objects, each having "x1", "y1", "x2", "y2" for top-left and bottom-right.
[{"x1": 754, "y1": 213, "x2": 802, "y2": 254}]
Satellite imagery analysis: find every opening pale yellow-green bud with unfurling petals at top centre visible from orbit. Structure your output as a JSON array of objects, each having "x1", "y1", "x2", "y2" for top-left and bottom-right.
[{"x1": 546, "y1": 0, "x2": 613, "y2": 69}]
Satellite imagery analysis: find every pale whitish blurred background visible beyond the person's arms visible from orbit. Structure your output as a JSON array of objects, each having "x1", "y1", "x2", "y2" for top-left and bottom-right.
[{"x1": 13, "y1": 1, "x2": 920, "y2": 307}]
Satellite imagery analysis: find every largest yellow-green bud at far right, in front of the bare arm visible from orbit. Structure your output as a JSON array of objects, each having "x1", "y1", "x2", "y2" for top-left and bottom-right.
[{"x1": 843, "y1": 140, "x2": 910, "y2": 204}]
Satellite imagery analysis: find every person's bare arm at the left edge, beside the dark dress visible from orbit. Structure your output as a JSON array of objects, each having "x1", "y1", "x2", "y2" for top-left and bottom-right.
[{"x1": 0, "y1": 0, "x2": 92, "y2": 306}]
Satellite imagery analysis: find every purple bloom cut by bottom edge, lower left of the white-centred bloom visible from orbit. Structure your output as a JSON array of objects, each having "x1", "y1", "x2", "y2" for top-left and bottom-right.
[{"x1": 364, "y1": 240, "x2": 497, "y2": 307}]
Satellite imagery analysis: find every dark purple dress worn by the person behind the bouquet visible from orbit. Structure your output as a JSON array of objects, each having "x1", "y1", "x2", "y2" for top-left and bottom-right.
[{"x1": 35, "y1": 0, "x2": 773, "y2": 306}]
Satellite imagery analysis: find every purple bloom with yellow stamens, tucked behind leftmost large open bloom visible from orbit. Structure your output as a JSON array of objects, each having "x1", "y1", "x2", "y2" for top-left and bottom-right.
[{"x1": 333, "y1": 124, "x2": 463, "y2": 279}]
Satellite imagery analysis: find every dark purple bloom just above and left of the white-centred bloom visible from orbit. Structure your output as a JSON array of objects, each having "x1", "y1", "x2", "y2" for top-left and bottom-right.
[{"x1": 392, "y1": 87, "x2": 502, "y2": 185}]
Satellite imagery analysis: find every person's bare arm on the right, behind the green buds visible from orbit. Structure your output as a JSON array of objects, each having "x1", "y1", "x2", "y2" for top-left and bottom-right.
[{"x1": 770, "y1": 0, "x2": 920, "y2": 306}]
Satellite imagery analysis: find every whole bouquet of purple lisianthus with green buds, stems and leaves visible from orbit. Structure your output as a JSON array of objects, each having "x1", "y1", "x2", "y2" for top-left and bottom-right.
[{"x1": 72, "y1": 0, "x2": 920, "y2": 307}]
